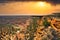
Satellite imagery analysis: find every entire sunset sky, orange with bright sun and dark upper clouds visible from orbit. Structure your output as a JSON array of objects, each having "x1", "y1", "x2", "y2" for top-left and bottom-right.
[{"x1": 0, "y1": 0, "x2": 60, "y2": 15}]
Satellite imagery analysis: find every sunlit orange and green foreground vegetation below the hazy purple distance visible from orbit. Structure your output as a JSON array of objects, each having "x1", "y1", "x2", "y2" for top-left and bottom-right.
[{"x1": 0, "y1": 17, "x2": 60, "y2": 40}]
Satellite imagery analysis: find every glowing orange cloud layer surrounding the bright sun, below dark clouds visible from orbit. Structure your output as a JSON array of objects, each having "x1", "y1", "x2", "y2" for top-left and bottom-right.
[{"x1": 0, "y1": 2, "x2": 60, "y2": 15}]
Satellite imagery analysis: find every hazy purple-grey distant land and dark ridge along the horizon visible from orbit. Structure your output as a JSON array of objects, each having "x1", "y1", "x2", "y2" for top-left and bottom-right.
[{"x1": 0, "y1": 13, "x2": 60, "y2": 24}]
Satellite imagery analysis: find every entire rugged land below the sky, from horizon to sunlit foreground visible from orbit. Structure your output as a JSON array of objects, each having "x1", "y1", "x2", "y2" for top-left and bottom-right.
[{"x1": 0, "y1": 13, "x2": 60, "y2": 40}]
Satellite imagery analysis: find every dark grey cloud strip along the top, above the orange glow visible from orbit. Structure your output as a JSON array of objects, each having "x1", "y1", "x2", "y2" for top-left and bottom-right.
[{"x1": 0, "y1": 0, "x2": 60, "y2": 4}]
